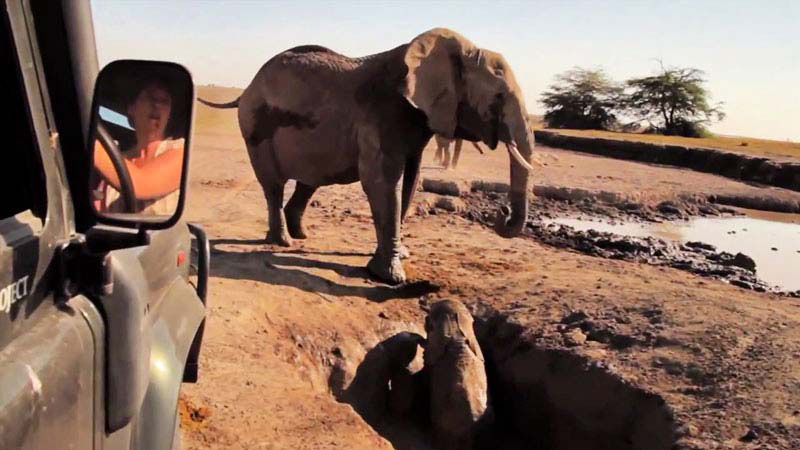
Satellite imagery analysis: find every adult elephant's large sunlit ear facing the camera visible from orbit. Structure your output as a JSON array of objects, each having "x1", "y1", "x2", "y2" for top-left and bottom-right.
[{"x1": 403, "y1": 28, "x2": 478, "y2": 138}]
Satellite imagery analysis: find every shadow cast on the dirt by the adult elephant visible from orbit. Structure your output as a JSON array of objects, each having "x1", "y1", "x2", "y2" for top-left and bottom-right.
[{"x1": 210, "y1": 239, "x2": 439, "y2": 303}]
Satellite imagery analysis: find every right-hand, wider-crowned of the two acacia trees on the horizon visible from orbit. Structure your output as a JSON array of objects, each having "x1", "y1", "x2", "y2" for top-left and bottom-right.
[{"x1": 624, "y1": 64, "x2": 725, "y2": 137}]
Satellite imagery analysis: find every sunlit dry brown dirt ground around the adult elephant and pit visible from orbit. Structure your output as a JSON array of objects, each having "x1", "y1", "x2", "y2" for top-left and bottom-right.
[{"x1": 180, "y1": 92, "x2": 800, "y2": 449}]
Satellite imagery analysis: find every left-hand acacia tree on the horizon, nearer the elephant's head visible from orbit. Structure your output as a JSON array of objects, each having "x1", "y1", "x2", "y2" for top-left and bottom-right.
[{"x1": 540, "y1": 67, "x2": 622, "y2": 130}]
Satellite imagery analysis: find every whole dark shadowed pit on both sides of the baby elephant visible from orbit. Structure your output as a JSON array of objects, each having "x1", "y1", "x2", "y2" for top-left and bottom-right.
[{"x1": 329, "y1": 307, "x2": 682, "y2": 450}]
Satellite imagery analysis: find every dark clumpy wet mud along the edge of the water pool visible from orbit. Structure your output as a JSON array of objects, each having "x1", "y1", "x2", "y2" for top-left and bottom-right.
[{"x1": 462, "y1": 192, "x2": 800, "y2": 297}]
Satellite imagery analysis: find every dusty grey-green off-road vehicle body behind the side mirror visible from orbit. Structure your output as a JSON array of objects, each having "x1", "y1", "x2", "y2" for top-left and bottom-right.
[{"x1": 0, "y1": 0, "x2": 207, "y2": 450}]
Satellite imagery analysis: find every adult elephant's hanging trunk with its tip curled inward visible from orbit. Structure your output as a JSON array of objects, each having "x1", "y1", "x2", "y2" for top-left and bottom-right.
[{"x1": 494, "y1": 110, "x2": 533, "y2": 238}]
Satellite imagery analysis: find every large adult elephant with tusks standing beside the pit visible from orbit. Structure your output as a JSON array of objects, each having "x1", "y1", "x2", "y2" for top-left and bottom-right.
[{"x1": 201, "y1": 28, "x2": 533, "y2": 284}]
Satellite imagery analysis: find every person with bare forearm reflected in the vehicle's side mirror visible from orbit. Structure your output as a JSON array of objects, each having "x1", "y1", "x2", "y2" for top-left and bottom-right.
[{"x1": 94, "y1": 77, "x2": 185, "y2": 215}]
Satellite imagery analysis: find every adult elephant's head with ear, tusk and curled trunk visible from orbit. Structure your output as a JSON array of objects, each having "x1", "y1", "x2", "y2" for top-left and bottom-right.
[{"x1": 403, "y1": 28, "x2": 533, "y2": 237}]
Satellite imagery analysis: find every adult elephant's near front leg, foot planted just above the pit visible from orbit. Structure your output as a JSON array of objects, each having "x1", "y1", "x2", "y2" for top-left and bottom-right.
[{"x1": 361, "y1": 177, "x2": 406, "y2": 284}]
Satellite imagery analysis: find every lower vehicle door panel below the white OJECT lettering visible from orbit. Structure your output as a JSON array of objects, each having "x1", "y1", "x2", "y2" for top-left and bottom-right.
[{"x1": 0, "y1": 296, "x2": 99, "y2": 450}]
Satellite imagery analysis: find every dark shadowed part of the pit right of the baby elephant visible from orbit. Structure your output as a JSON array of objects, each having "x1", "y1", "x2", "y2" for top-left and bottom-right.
[{"x1": 476, "y1": 315, "x2": 679, "y2": 450}]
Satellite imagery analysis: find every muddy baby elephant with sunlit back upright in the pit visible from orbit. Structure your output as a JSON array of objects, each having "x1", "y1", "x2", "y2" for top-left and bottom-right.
[{"x1": 424, "y1": 300, "x2": 492, "y2": 450}]
